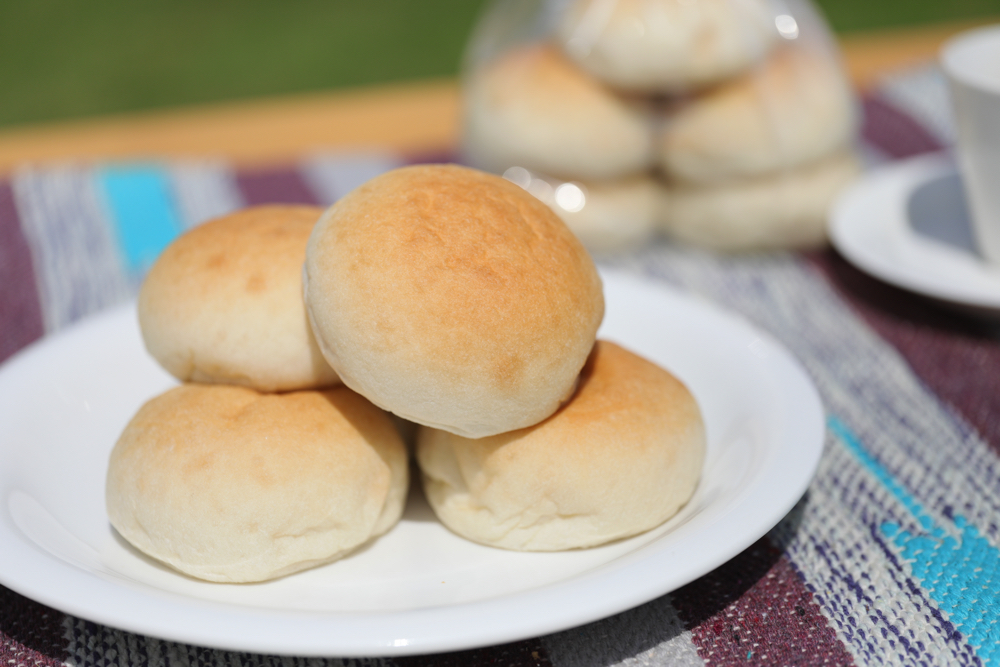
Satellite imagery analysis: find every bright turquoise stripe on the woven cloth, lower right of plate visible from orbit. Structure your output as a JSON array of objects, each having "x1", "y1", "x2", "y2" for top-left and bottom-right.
[{"x1": 828, "y1": 417, "x2": 1000, "y2": 665}]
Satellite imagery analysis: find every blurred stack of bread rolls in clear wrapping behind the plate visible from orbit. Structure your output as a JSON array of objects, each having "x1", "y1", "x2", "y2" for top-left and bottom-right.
[{"x1": 463, "y1": 0, "x2": 859, "y2": 250}]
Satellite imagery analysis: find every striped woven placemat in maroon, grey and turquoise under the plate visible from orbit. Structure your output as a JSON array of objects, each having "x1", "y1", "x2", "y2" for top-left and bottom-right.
[{"x1": 0, "y1": 69, "x2": 1000, "y2": 666}]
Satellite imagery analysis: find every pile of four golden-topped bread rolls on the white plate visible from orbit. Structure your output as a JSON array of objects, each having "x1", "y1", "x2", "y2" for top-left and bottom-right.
[{"x1": 107, "y1": 165, "x2": 705, "y2": 582}]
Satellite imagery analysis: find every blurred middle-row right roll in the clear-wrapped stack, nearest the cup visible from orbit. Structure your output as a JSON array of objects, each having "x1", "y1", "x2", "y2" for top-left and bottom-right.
[{"x1": 659, "y1": 46, "x2": 856, "y2": 183}]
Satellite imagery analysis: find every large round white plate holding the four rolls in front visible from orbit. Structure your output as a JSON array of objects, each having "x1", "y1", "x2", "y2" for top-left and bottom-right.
[{"x1": 0, "y1": 274, "x2": 824, "y2": 656}]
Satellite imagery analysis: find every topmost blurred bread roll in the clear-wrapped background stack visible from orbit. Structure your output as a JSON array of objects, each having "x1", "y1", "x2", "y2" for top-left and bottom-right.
[{"x1": 557, "y1": 0, "x2": 778, "y2": 93}]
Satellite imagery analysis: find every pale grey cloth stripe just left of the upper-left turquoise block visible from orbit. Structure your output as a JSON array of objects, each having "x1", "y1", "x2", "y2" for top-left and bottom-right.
[{"x1": 11, "y1": 166, "x2": 136, "y2": 333}]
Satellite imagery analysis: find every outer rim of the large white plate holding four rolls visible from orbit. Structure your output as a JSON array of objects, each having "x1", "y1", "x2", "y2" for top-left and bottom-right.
[{"x1": 0, "y1": 269, "x2": 825, "y2": 657}]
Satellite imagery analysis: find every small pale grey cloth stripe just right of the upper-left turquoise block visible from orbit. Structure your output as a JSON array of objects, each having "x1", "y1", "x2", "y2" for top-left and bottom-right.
[{"x1": 169, "y1": 161, "x2": 245, "y2": 229}]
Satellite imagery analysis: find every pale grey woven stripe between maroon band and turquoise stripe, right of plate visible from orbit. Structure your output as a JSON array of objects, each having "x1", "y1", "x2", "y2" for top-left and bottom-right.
[{"x1": 616, "y1": 247, "x2": 1000, "y2": 544}]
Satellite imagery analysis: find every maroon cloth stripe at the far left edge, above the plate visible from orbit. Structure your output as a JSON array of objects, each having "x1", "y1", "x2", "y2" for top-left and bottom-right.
[{"x1": 0, "y1": 183, "x2": 45, "y2": 361}]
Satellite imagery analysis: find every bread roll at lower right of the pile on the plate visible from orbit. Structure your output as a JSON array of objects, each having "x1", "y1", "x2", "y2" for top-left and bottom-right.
[{"x1": 417, "y1": 341, "x2": 705, "y2": 551}]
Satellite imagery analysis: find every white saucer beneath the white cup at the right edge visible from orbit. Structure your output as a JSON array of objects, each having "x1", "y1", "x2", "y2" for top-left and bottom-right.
[{"x1": 830, "y1": 154, "x2": 1000, "y2": 312}]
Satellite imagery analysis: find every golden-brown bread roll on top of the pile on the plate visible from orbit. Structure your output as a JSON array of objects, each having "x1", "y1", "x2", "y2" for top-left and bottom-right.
[{"x1": 305, "y1": 165, "x2": 604, "y2": 438}]
